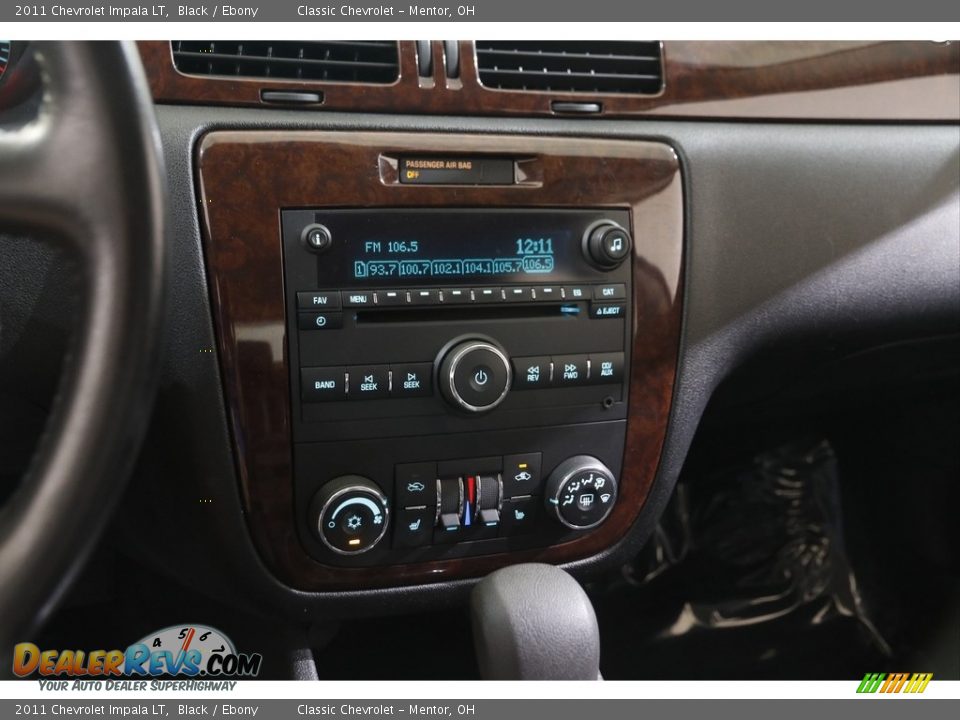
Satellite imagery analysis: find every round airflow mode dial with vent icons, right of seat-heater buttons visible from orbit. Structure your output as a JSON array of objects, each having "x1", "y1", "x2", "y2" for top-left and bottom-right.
[{"x1": 545, "y1": 455, "x2": 617, "y2": 530}]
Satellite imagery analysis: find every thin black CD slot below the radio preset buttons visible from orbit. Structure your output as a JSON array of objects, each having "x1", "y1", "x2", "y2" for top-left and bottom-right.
[{"x1": 357, "y1": 302, "x2": 587, "y2": 325}]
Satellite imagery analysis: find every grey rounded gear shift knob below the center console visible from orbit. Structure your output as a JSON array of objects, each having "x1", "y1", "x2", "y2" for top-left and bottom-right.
[{"x1": 470, "y1": 563, "x2": 600, "y2": 680}]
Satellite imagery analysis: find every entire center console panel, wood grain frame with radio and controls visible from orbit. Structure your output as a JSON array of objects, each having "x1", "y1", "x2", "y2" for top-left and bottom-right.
[{"x1": 198, "y1": 132, "x2": 682, "y2": 589}]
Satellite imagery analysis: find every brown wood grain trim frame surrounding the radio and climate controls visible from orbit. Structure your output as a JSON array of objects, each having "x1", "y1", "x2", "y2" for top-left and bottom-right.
[{"x1": 196, "y1": 132, "x2": 683, "y2": 590}]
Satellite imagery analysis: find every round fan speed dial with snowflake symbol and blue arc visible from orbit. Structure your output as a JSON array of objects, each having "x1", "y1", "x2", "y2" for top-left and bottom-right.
[{"x1": 311, "y1": 475, "x2": 390, "y2": 555}]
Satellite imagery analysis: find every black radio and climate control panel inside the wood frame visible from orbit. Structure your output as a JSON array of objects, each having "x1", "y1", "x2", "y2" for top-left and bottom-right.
[{"x1": 282, "y1": 208, "x2": 632, "y2": 565}]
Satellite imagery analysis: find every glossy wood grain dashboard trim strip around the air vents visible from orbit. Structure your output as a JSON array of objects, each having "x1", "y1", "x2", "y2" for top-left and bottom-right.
[{"x1": 139, "y1": 41, "x2": 960, "y2": 122}]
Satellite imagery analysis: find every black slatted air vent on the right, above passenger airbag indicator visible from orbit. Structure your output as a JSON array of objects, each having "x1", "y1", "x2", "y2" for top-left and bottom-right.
[{"x1": 476, "y1": 40, "x2": 663, "y2": 95}]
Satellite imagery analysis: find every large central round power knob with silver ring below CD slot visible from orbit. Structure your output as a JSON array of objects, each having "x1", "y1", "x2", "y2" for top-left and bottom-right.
[{"x1": 438, "y1": 340, "x2": 512, "y2": 413}]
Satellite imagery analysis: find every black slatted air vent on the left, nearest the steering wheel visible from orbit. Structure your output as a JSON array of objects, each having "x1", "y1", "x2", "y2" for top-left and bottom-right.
[{"x1": 171, "y1": 40, "x2": 400, "y2": 85}]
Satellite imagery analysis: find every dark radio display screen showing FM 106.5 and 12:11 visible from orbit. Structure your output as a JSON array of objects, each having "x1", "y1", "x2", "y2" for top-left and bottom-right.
[{"x1": 300, "y1": 210, "x2": 627, "y2": 287}]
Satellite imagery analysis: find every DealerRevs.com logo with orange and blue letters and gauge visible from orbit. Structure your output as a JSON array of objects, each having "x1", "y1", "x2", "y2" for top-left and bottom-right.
[{"x1": 13, "y1": 625, "x2": 263, "y2": 679}]
